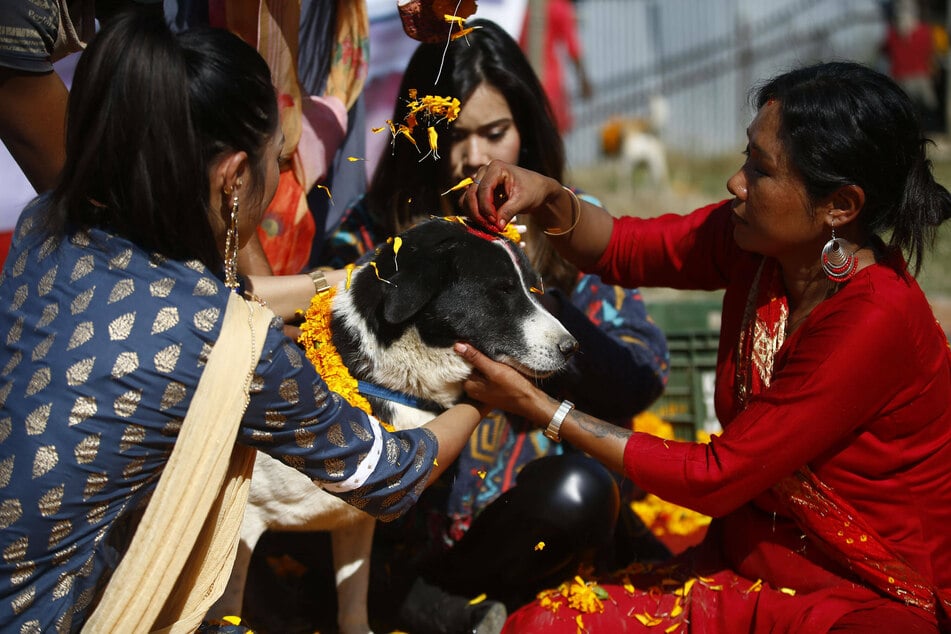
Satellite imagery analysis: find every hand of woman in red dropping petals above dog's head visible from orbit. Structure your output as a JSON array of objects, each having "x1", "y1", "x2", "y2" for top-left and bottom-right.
[{"x1": 462, "y1": 161, "x2": 571, "y2": 229}]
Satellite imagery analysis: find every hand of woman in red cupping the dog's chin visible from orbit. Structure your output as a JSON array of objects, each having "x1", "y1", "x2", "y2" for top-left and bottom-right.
[{"x1": 455, "y1": 343, "x2": 558, "y2": 426}]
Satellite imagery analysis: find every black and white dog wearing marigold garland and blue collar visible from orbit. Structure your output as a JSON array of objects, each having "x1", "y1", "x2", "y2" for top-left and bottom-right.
[{"x1": 210, "y1": 218, "x2": 578, "y2": 634}]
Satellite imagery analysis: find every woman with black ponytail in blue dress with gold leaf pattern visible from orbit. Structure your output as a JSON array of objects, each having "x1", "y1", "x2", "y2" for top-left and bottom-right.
[{"x1": 0, "y1": 13, "x2": 498, "y2": 632}]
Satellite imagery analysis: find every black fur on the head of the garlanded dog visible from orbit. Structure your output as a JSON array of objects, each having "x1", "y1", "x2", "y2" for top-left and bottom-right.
[{"x1": 332, "y1": 219, "x2": 542, "y2": 370}]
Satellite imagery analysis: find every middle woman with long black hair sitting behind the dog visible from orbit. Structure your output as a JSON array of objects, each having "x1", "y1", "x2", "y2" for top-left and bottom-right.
[{"x1": 321, "y1": 20, "x2": 669, "y2": 633}]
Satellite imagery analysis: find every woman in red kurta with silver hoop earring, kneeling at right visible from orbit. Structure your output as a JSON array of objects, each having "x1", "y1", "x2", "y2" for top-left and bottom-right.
[{"x1": 459, "y1": 63, "x2": 951, "y2": 633}]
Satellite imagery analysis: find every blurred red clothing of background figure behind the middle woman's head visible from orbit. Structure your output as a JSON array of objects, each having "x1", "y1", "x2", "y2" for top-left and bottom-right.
[{"x1": 519, "y1": 0, "x2": 581, "y2": 133}]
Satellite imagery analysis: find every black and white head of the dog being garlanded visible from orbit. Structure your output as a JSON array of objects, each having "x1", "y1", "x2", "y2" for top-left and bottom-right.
[{"x1": 333, "y1": 218, "x2": 577, "y2": 400}]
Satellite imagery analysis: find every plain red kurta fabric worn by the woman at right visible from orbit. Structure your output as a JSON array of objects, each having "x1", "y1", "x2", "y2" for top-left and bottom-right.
[{"x1": 512, "y1": 203, "x2": 951, "y2": 632}]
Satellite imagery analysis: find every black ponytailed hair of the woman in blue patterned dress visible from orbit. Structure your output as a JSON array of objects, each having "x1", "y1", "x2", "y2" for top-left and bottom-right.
[{"x1": 43, "y1": 10, "x2": 278, "y2": 269}]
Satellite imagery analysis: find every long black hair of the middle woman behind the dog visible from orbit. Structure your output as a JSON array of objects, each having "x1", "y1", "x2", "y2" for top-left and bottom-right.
[{"x1": 366, "y1": 20, "x2": 577, "y2": 292}]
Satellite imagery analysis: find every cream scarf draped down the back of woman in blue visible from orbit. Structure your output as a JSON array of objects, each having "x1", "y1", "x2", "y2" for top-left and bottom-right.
[{"x1": 83, "y1": 294, "x2": 274, "y2": 634}]
